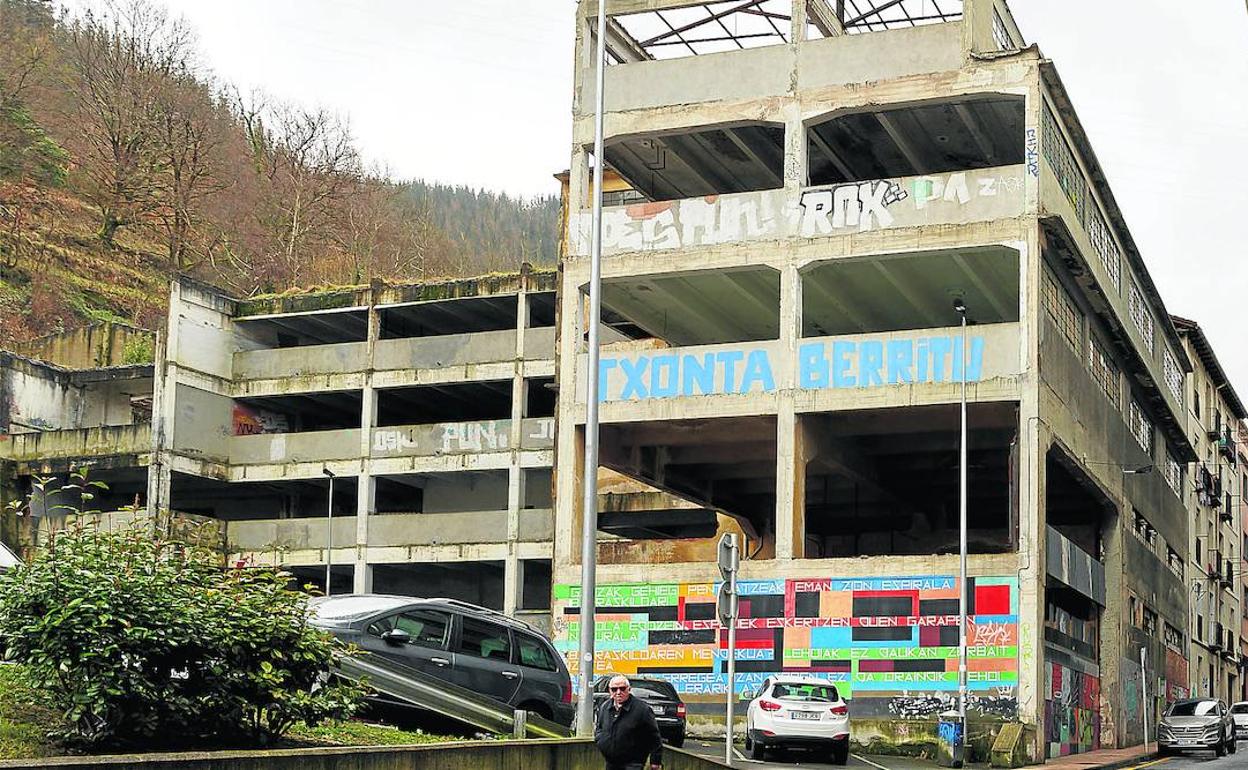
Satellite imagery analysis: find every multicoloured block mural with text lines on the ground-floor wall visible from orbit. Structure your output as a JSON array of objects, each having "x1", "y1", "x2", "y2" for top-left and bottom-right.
[{"x1": 554, "y1": 575, "x2": 1018, "y2": 716}]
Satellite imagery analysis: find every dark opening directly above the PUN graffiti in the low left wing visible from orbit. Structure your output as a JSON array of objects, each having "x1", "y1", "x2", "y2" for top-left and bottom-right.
[{"x1": 377, "y1": 379, "x2": 512, "y2": 427}]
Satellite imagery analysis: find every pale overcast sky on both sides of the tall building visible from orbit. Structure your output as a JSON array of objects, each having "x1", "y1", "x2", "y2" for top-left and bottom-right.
[{"x1": 65, "y1": 0, "x2": 1248, "y2": 389}]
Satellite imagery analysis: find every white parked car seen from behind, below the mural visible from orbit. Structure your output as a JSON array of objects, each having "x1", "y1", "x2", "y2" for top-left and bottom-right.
[{"x1": 745, "y1": 674, "x2": 850, "y2": 765}]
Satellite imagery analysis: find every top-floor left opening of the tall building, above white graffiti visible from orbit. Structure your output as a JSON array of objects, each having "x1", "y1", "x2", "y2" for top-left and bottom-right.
[{"x1": 594, "y1": 124, "x2": 784, "y2": 201}]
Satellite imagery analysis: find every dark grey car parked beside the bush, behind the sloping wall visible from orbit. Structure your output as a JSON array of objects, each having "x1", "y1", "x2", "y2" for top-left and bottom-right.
[{"x1": 310, "y1": 594, "x2": 575, "y2": 725}]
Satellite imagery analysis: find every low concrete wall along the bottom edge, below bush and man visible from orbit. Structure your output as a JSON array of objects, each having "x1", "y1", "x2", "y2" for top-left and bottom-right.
[{"x1": 0, "y1": 739, "x2": 726, "y2": 770}]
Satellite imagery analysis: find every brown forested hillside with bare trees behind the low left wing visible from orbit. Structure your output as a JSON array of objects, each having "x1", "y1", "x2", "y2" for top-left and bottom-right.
[{"x1": 0, "y1": 0, "x2": 559, "y2": 344}]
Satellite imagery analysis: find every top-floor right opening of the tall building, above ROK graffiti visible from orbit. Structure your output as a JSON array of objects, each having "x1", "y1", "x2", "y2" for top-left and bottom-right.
[{"x1": 806, "y1": 95, "x2": 1026, "y2": 185}]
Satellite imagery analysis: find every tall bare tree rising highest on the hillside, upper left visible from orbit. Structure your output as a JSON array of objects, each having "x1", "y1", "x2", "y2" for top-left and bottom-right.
[{"x1": 67, "y1": 0, "x2": 195, "y2": 245}]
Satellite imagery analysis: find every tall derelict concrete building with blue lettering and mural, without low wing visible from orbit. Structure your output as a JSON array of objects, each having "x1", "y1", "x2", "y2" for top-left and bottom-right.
[{"x1": 554, "y1": 0, "x2": 1197, "y2": 755}]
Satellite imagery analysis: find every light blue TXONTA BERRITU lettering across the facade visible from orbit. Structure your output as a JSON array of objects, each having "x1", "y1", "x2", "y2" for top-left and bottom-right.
[{"x1": 598, "y1": 337, "x2": 985, "y2": 402}]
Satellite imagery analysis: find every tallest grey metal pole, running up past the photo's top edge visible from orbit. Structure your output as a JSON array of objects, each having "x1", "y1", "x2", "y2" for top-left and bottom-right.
[{"x1": 570, "y1": 0, "x2": 607, "y2": 736}]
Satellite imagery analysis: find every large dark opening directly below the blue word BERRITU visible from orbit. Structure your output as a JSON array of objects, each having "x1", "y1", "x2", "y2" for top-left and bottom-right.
[{"x1": 802, "y1": 403, "x2": 1017, "y2": 558}]
